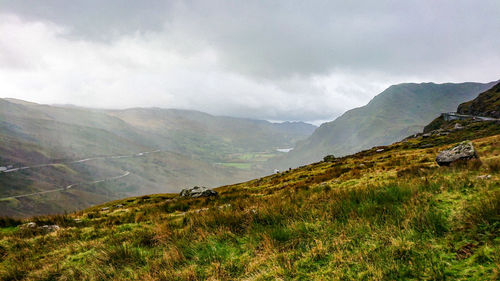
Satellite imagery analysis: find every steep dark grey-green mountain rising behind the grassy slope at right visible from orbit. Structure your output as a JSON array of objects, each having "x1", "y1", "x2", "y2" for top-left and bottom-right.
[{"x1": 269, "y1": 82, "x2": 495, "y2": 168}]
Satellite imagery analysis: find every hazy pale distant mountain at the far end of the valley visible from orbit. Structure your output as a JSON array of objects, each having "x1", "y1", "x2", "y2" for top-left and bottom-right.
[{"x1": 106, "y1": 108, "x2": 316, "y2": 162}]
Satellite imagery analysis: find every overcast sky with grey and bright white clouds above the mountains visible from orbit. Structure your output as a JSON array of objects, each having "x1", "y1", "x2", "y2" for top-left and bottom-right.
[{"x1": 0, "y1": 0, "x2": 500, "y2": 123}]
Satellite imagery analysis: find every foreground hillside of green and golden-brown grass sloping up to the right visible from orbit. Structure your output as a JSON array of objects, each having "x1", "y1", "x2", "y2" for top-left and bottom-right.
[{"x1": 0, "y1": 122, "x2": 500, "y2": 280}]
